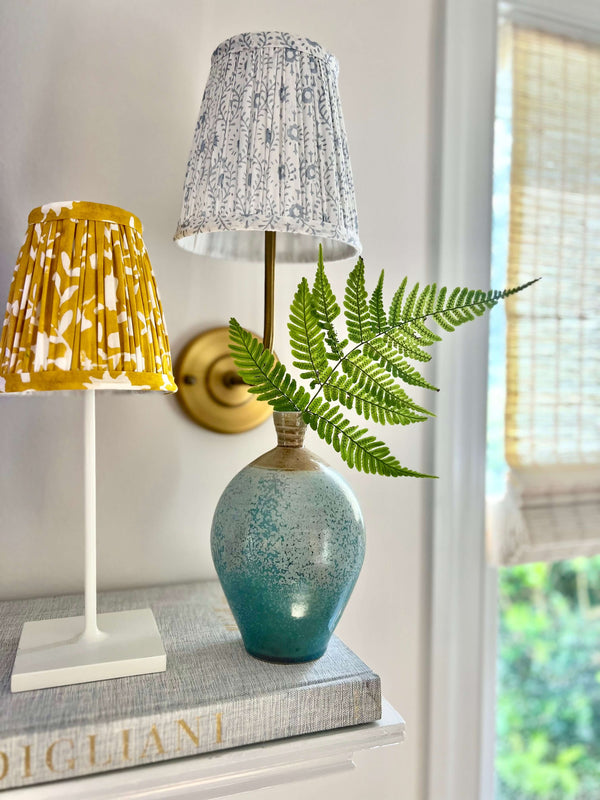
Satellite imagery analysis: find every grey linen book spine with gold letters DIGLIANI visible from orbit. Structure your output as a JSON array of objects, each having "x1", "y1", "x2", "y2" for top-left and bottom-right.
[{"x1": 0, "y1": 672, "x2": 381, "y2": 790}]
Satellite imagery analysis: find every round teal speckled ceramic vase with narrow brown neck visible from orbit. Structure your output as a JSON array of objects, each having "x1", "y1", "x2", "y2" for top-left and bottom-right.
[{"x1": 211, "y1": 411, "x2": 365, "y2": 663}]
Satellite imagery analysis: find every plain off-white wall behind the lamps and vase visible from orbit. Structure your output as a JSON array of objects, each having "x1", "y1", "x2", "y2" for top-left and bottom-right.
[{"x1": 0, "y1": 0, "x2": 436, "y2": 800}]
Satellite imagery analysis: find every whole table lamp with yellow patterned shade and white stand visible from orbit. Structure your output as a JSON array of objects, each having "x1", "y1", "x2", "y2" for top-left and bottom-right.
[{"x1": 0, "y1": 202, "x2": 176, "y2": 692}]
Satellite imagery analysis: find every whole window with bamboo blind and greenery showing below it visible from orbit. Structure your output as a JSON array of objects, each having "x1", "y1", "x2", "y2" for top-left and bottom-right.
[{"x1": 487, "y1": 17, "x2": 600, "y2": 800}]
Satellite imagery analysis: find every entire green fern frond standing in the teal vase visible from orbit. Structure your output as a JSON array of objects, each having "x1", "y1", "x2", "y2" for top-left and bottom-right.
[{"x1": 230, "y1": 253, "x2": 535, "y2": 477}]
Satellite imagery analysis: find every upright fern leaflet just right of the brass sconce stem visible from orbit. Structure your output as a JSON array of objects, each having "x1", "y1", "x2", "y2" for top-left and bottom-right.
[{"x1": 288, "y1": 278, "x2": 331, "y2": 384}]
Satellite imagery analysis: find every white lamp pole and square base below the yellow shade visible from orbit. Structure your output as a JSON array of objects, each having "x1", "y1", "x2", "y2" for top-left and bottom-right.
[{"x1": 10, "y1": 390, "x2": 167, "y2": 692}]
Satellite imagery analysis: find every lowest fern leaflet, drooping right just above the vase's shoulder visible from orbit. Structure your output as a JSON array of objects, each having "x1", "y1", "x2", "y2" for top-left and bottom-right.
[{"x1": 303, "y1": 398, "x2": 433, "y2": 478}]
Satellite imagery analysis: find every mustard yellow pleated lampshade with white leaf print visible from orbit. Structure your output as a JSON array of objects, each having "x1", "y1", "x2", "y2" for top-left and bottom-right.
[{"x1": 0, "y1": 201, "x2": 177, "y2": 392}]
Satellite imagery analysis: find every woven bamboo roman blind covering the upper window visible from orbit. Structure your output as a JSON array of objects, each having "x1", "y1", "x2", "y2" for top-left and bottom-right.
[{"x1": 492, "y1": 26, "x2": 600, "y2": 563}]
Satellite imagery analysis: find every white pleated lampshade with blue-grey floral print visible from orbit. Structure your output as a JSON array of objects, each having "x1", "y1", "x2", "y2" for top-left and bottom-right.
[{"x1": 175, "y1": 32, "x2": 361, "y2": 262}]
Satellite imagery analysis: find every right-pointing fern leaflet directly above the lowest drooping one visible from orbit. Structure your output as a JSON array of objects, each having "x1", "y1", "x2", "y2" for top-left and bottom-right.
[{"x1": 322, "y1": 372, "x2": 429, "y2": 425}]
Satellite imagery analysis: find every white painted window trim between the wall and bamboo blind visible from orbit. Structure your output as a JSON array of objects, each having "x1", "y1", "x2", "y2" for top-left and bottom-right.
[{"x1": 425, "y1": 0, "x2": 600, "y2": 800}]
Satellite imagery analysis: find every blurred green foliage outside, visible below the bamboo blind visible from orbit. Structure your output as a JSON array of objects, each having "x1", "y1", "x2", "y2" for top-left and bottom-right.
[{"x1": 496, "y1": 557, "x2": 600, "y2": 800}]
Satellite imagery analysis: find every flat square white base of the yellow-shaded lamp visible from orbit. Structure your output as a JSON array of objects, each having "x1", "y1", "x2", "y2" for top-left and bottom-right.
[{"x1": 10, "y1": 608, "x2": 167, "y2": 692}]
